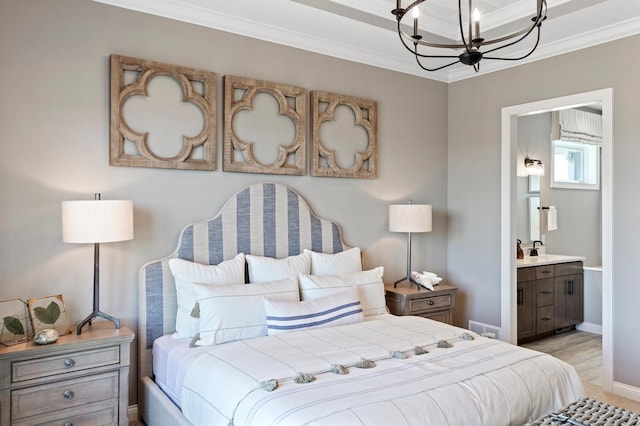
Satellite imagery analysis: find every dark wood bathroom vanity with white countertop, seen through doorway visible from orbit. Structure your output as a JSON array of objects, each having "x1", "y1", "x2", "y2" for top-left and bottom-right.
[{"x1": 516, "y1": 254, "x2": 584, "y2": 343}]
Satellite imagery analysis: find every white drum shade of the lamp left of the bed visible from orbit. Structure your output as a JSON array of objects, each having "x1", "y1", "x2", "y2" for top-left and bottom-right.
[{"x1": 62, "y1": 200, "x2": 133, "y2": 243}]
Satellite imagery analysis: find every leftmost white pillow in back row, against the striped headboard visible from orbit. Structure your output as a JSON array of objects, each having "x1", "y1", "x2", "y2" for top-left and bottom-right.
[{"x1": 169, "y1": 253, "x2": 244, "y2": 337}]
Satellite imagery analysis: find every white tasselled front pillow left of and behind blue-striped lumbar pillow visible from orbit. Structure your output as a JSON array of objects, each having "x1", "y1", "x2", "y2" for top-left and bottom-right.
[{"x1": 193, "y1": 278, "x2": 300, "y2": 346}]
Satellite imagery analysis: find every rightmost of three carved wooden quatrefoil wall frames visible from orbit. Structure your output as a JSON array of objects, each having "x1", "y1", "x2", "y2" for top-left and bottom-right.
[{"x1": 311, "y1": 90, "x2": 378, "y2": 179}]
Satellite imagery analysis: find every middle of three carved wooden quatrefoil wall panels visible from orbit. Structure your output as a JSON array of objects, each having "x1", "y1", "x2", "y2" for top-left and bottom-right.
[{"x1": 223, "y1": 75, "x2": 307, "y2": 176}]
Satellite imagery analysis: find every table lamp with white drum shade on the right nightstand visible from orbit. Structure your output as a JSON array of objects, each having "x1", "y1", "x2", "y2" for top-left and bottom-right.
[{"x1": 389, "y1": 202, "x2": 431, "y2": 288}]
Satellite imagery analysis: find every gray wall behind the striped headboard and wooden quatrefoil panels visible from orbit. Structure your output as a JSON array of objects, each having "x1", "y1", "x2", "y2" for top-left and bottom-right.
[{"x1": 0, "y1": 0, "x2": 447, "y2": 401}]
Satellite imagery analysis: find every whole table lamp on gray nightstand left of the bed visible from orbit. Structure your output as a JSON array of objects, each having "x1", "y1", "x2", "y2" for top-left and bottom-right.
[{"x1": 62, "y1": 194, "x2": 133, "y2": 334}]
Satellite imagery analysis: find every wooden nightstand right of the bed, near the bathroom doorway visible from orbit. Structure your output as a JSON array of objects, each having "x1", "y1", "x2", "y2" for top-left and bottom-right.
[{"x1": 384, "y1": 282, "x2": 458, "y2": 324}]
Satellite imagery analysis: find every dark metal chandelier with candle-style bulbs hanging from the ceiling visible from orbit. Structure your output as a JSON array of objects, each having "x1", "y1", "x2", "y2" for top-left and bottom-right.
[{"x1": 391, "y1": 0, "x2": 547, "y2": 72}]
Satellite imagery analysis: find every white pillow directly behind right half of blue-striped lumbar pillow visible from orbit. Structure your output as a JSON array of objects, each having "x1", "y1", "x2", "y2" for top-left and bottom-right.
[{"x1": 300, "y1": 266, "x2": 387, "y2": 317}]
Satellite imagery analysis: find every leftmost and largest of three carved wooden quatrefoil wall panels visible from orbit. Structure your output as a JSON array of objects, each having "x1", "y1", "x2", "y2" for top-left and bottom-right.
[{"x1": 109, "y1": 55, "x2": 217, "y2": 170}]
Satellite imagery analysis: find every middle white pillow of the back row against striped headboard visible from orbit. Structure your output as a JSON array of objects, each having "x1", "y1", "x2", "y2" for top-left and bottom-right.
[{"x1": 246, "y1": 253, "x2": 311, "y2": 283}]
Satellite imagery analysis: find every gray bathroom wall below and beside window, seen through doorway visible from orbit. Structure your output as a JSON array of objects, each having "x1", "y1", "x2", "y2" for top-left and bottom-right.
[{"x1": 516, "y1": 113, "x2": 602, "y2": 266}]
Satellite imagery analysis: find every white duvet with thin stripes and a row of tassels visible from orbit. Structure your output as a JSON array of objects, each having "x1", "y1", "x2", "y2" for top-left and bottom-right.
[{"x1": 182, "y1": 315, "x2": 584, "y2": 426}]
